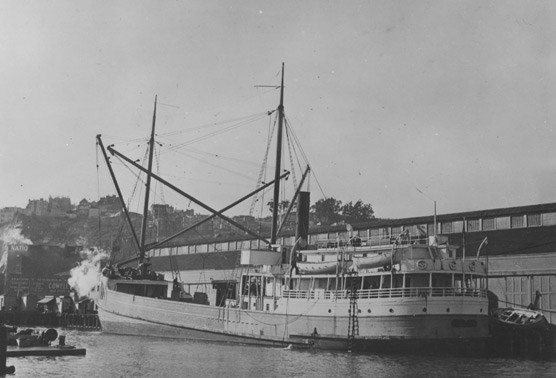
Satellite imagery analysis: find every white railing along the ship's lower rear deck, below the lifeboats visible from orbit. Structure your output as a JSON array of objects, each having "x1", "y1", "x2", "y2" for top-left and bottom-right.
[{"x1": 282, "y1": 287, "x2": 487, "y2": 299}]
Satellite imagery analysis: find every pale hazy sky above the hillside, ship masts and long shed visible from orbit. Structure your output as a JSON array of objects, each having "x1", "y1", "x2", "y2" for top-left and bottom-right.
[{"x1": 0, "y1": 0, "x2": 556, "y2": 218}]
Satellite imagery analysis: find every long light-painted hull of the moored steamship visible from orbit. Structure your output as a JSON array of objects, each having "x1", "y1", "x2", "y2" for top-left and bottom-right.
[{"x1": 97, "y1": 278, "x2": 488, "y2": 350}]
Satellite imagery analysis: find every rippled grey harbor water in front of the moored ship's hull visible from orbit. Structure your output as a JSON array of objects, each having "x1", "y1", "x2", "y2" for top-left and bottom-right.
[{"x1": 8, "y1": 329, "x2": 556, "y2": 377}]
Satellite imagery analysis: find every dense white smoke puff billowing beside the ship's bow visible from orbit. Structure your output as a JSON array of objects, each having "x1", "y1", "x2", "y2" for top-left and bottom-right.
[{"x1": 68, "y1": 247, "x2": 109, "y2": 297}]
